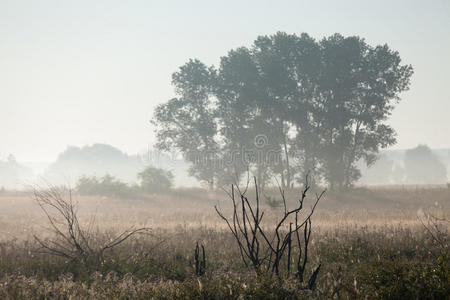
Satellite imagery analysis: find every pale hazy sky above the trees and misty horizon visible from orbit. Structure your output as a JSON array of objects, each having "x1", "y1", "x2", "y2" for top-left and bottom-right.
[{"x1": 0, "y1": 0, "x2": 450, "y2": 161}]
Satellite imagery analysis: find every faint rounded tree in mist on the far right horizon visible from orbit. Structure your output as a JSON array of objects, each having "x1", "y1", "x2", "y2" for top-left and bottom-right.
[{"x1": 405, "y1": 145, "x2": 447, "y2": 183}]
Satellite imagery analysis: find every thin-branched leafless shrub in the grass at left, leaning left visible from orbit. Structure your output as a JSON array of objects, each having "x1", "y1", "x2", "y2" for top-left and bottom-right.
[{"x1": 34, "y1": 186, "x2": 150, "y2": 265}]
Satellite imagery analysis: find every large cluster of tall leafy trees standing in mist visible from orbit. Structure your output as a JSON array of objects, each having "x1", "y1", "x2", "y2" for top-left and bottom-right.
[{"x1": 152, "y1": 32, "x2": 413, "y2": 189}]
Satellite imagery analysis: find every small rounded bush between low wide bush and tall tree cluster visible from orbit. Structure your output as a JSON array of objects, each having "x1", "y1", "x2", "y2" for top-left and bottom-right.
[{"x1": 138, "y1": 167, "x2": 173, "y2": 193}]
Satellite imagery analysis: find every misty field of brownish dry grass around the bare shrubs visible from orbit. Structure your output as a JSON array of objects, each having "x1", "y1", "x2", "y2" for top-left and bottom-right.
[{"x1": 0, "y1": 186, "x2": 450, "y2": 299}]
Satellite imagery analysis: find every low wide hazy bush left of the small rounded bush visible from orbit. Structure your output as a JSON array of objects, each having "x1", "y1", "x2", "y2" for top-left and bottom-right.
[{"x1": 75, "y1": 175, "x2": 136, "y2": 198}]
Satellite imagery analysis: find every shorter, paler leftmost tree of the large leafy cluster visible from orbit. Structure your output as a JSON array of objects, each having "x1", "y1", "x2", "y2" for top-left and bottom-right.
[{"x1": 151, "y1": 60, "x2": 219, "y2": 189}]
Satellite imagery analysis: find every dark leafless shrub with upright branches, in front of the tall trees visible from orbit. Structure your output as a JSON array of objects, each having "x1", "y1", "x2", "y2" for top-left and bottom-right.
[{"x1": 215, "y1": 176, "x2": 325, "y2": 289}]
